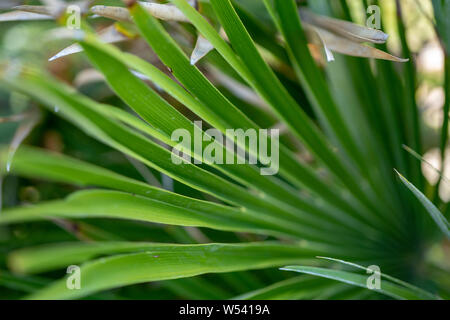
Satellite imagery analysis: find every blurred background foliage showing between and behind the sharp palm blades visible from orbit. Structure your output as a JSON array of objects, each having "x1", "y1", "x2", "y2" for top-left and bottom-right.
[{"x1": 0, "y1": 0, "x2": 450, "y2": 299}]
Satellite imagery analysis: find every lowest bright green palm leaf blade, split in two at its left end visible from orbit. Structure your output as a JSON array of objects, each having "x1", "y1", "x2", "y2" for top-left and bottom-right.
[{"x1": 11, "y1": 242, "x2": 324, "y2": 299}]
